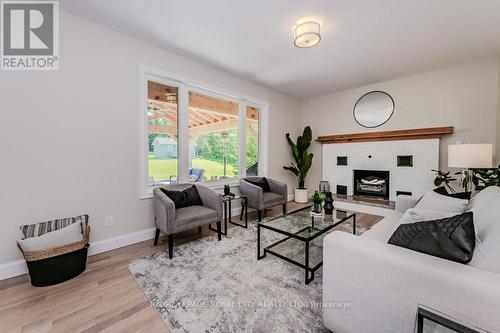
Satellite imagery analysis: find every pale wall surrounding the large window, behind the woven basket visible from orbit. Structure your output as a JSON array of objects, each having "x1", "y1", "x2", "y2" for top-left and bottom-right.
[{"x1": 0, "y1": 12, "x2": 301, "y2": 264}]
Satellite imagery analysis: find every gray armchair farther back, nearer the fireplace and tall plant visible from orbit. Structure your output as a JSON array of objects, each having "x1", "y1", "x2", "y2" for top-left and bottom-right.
[{"x1": 240, "y1": 177, "x2": 288, "y2": 222}]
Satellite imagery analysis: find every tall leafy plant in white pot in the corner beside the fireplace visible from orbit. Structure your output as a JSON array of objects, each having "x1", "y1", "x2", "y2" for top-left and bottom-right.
[{"x1": 283, "y1": 126, "x2": 313, "y2": 203}]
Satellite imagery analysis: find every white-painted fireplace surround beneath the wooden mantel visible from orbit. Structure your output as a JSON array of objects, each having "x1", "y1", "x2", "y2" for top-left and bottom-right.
[{"x1": 323, "y1": 139, "x2": 439, "y2": 201}]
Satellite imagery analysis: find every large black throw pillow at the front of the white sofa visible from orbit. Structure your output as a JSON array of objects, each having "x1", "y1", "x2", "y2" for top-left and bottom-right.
[{"x1": 388, "y1": 212, "x2": 476, "y2": 264}]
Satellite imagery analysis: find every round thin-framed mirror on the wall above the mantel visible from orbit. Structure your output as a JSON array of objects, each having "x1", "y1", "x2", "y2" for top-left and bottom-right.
[{"x1": 353, "y1": 91, "x2": 394, "y2": 128}]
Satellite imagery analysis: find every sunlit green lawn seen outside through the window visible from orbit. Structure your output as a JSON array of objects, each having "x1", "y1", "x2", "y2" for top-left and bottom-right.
[{"x1": 149, "y1": 154, "x2": 233, "y2": 180}]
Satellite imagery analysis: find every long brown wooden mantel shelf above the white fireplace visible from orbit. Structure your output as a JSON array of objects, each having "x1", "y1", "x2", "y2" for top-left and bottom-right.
[{"x1": 316, "y1": 126, "x2": 453, "y2": 143}]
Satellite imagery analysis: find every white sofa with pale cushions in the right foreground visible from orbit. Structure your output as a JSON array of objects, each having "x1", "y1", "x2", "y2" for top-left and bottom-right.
[{"x1": 323, "y1": 187, "x2": 500, "y2": 333}]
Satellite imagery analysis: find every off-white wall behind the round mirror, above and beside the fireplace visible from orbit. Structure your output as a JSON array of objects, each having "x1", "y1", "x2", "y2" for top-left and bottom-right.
[{"x1": 302, "y1": 57, "x2": 500, "y2": 189}]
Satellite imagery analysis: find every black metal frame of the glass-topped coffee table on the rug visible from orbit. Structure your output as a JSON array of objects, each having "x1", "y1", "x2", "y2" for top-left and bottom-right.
[{"x1": 257, "y1": 207, "x2": 356, "y2": 284}]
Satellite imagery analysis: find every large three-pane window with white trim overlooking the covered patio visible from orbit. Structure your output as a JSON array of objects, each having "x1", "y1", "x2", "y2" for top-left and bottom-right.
[{"x1": 141, "y1": 67, "x2": 267, "y2": 197}]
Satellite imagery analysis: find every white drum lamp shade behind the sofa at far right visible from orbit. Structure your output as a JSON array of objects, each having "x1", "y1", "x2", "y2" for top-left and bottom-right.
[{"x1": 448, "y1": 143, "x2": 493, "y2": 169}]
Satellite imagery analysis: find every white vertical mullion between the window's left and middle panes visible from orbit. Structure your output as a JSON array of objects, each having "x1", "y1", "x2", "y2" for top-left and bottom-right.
[{"x1": 177, "y1": 85, "x2": 189, "y2": 183}]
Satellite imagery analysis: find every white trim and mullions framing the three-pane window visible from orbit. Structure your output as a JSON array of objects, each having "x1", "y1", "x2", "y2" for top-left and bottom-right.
[{"x1": 139, "y1": 64, "x2": 269, "y2": 199}]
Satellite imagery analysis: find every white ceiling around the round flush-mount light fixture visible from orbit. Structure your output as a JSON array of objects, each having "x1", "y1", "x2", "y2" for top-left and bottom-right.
[{"x1": 60, "y1": 0, "x2": 500, "y2": 98}]
